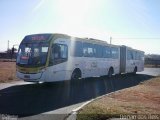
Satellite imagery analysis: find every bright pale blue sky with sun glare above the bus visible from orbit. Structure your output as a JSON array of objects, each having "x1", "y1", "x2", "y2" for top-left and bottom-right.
[{"x1": 0, "y1": 0, "x2": 160, "y2": 54}]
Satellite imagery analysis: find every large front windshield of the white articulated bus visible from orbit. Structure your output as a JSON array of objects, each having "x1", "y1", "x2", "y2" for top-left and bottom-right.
[{"x1": 17, "y1": 43, "x2": 49, "y2": 67}]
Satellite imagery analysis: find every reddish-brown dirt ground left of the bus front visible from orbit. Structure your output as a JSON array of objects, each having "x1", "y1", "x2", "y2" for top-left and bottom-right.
[{"x1": 0, "y1": 62, "x2": 18, "y2": 83}]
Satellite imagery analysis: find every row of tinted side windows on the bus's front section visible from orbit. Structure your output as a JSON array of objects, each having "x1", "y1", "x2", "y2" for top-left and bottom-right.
[{"x1": 71, "y1": 41, "x2": 119, "y2": 59}]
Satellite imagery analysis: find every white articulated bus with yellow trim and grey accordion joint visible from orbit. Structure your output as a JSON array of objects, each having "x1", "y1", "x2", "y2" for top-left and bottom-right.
[{"x1": 16, "y1": 34, "x2": 144, "y2": 82}]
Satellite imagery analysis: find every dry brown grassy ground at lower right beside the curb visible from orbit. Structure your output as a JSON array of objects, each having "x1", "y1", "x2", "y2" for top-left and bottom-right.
[{"x1": 77, "y1": 77, "x2": 160, "y2": 120}]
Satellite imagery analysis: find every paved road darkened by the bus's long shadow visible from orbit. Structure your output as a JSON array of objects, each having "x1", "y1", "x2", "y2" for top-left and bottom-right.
[{"x1": 0, "y1": 68, "x2": 160, "y2": 120}]
